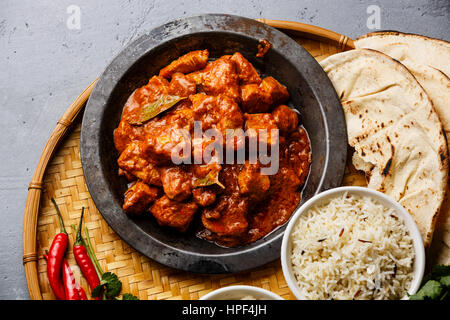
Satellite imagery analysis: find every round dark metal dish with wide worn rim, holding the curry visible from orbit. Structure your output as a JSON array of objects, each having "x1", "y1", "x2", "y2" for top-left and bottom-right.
[{"x1": 81, "y1": 14, "x2": 347, "y2": 273}]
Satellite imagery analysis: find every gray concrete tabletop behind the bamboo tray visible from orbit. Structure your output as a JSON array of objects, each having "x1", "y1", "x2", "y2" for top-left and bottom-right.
[{"x1": 0, "y1": 0, "x2": 450, "y2": 299}]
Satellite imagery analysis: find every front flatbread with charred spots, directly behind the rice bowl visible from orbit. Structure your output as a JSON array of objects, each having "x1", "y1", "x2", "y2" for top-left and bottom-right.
[{"x1": 321, "y1": 49, "x2": 448, "y2": 247}]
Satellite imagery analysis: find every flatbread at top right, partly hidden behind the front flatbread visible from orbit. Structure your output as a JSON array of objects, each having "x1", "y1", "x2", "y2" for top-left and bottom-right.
[{"x1": 355, "y1": 32, "x2": 450, "y2": 264}]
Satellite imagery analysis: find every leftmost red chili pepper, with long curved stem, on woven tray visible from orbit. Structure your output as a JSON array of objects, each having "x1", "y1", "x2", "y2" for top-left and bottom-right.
[{"x1": 47, "y1": 198, "x2": 69, "y2": 300}]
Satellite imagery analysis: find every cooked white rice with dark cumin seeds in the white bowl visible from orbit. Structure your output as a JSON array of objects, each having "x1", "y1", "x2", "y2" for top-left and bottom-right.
[{"x1": 291, "y1": 193, "x2": 414, "y2": 300}]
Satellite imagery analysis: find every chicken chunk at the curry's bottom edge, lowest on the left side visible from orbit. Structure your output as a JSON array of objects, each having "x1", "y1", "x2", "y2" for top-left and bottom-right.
[{"x1": 150, "y1": 195, "x2": 198, "y2": 232}]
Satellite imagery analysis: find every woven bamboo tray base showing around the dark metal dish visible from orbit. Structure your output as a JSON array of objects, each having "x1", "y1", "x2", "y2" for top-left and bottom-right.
[{"x1": 37, "y1": 38, "x2": 358, "y2": 300}]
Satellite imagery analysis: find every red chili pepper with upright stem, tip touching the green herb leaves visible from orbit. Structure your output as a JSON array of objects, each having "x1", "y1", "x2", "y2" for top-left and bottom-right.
[{"x1": 73, "y1": 208, "x2": 101, "y2": 300}]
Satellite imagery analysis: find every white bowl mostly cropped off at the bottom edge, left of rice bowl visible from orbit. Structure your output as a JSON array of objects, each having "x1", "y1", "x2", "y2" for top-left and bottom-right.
[{"x1": 200, "y1": 286, "x2": 284, "y2": 300}]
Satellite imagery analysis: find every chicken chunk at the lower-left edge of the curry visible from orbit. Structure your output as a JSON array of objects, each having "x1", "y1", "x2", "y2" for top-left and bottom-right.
[{"x1": 123, "y1": 181, "x2": 159, "y2": 215}]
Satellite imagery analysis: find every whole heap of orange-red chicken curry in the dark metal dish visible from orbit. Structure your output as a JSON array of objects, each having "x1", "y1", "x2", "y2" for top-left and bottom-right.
[{"x1": 114, "y1": 50, "x2": 311, "y2": 247}]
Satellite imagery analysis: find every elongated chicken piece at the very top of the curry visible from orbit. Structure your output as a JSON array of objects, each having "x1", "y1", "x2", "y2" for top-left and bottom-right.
[{"x1": 159, "y1": 50, "x2": 209, "y2": 79}]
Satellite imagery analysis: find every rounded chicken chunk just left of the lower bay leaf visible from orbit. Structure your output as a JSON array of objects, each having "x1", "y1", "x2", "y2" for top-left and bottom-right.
[{"x1": 161, "y1": 166, "x2": 192, "y2": 201}]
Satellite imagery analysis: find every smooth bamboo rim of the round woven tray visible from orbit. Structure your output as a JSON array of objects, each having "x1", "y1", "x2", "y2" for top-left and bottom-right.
[{"x1": 22, "y1": 19, "x2": 354, "y2": 300}]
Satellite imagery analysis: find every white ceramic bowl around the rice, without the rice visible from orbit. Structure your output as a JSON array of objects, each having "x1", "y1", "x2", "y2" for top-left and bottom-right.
[{"x1": 281, "y1": 187, "x2": 425, "y2": 300}]
